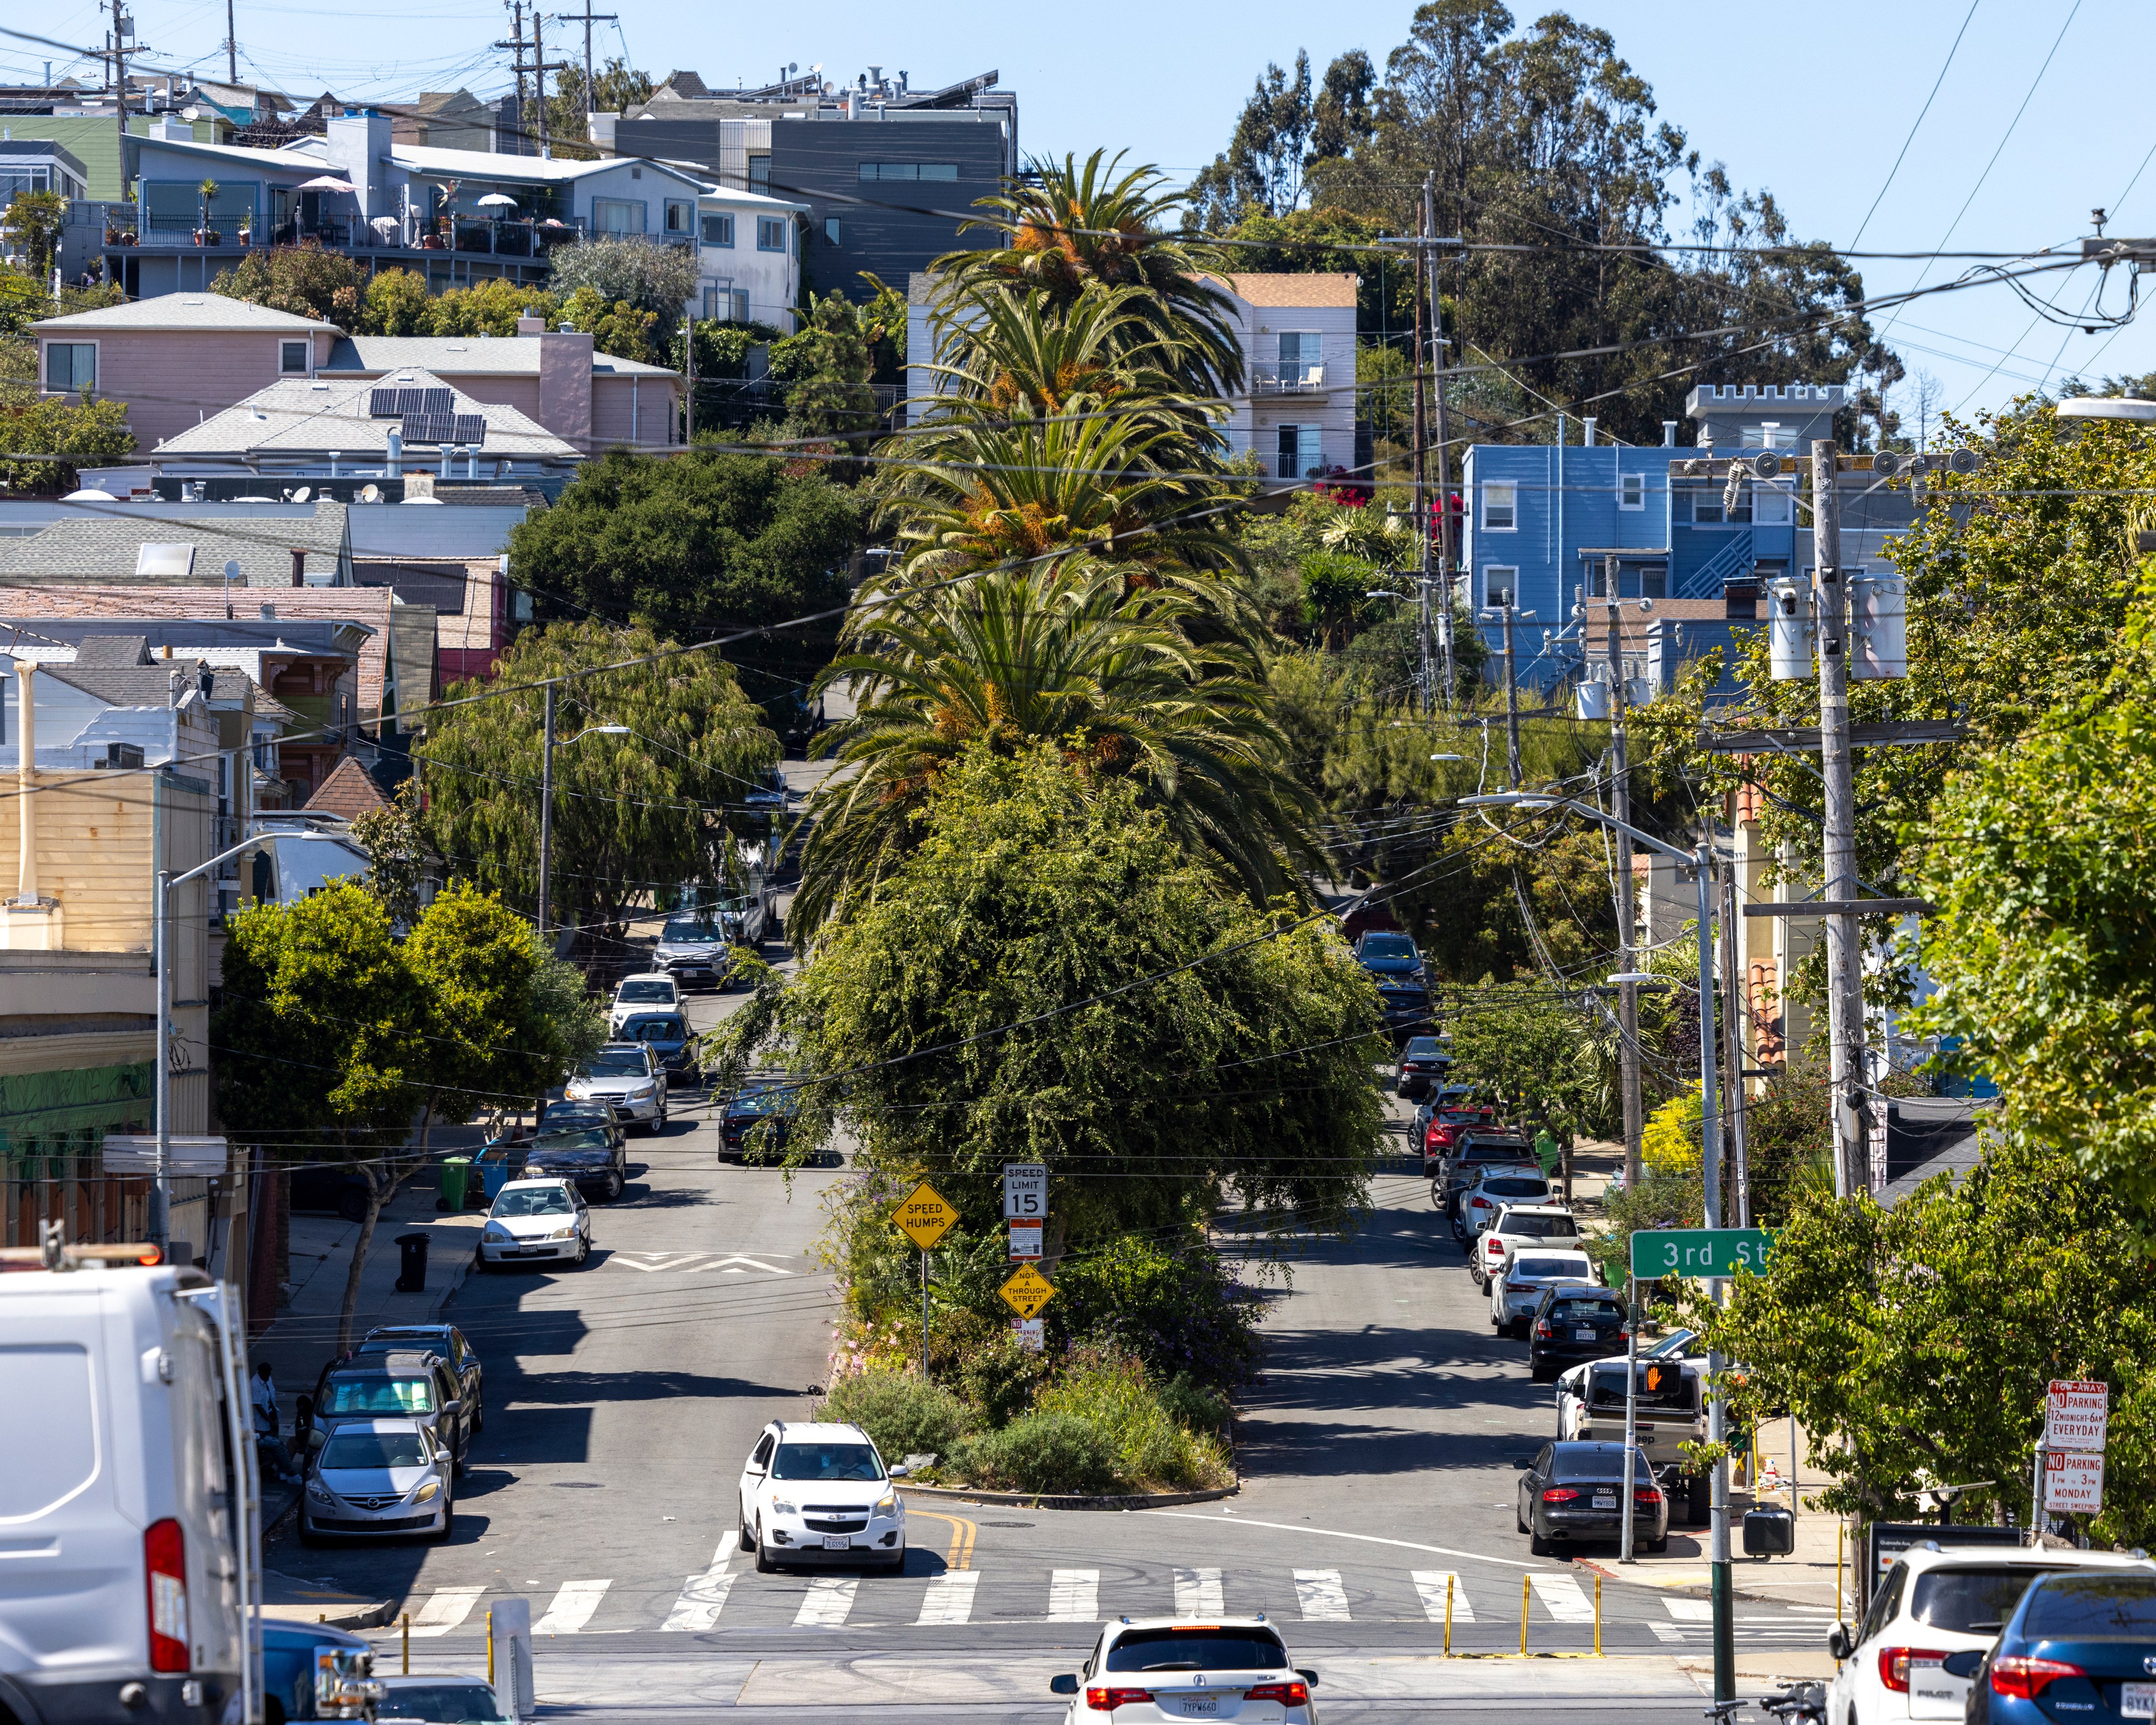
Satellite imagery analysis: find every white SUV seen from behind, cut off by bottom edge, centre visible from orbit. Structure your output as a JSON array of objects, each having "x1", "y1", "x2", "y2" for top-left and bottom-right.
[{"x1": 1048, "y1": 1617, "x2": 1317, "y2": 1725}]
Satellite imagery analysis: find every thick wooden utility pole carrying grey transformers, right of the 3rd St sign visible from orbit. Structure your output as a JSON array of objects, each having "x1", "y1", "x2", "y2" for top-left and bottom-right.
[{"x1": 1811, "y1": 438, "x2": 1871, "y2": 1199}]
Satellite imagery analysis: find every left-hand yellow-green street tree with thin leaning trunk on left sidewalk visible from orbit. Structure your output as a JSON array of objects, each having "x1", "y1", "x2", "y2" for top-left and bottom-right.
[{"x1": 211, "y1": 880, "x2": 429, "y2": 1352}]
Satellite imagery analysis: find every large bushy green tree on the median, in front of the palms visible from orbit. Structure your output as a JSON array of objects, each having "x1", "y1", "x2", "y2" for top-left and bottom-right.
[{"x1": 718, "y1": 742, "x2": 1380, "y2": 1259}]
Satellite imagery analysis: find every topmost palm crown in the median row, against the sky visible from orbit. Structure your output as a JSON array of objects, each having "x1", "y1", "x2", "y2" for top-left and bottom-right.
[{"x1": 929, "y1": 151, "x2": 1242, "y2": 399}]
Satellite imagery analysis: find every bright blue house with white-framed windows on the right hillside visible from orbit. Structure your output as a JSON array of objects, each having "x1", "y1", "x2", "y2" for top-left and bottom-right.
[{"x1": 1462, "y1": 384, "x2": 1880, "y2": 694}]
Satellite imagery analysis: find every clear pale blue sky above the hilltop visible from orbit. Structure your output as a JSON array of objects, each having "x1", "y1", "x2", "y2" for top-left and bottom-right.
[{"x1": 12, "y1": 0, "x2": 2156, "y2": 416}]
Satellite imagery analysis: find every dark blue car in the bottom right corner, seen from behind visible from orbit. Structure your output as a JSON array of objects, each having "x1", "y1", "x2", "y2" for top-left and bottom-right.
[{"x1": 1943, "y1": 1568, "x2": 2156, "y2": 1725}]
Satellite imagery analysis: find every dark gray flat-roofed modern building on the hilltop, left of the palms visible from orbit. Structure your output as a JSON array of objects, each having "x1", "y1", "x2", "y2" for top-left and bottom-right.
[{"x1": 593, "y1": 67, "x2": 1020, "y2": 300}]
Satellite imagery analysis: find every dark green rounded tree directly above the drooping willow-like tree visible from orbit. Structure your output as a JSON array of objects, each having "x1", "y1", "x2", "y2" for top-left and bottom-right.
[{"x1": 509, "y1": 449, "x2": 862, "y2": 703}]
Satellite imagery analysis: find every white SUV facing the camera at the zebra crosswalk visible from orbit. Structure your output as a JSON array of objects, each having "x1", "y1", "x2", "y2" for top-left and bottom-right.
[{"x1": 742, "y1": 1419, "x2": 906, "y2": 1574}]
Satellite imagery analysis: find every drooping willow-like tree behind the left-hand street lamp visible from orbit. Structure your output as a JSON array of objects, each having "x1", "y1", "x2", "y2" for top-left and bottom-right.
[{"x1": 412, "y1": 623, "x2": 778, "y2": 938}]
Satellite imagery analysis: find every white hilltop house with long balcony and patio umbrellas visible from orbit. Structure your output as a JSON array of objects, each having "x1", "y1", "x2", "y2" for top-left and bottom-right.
[{"x1": 88, "y1": 110, "x2": 703, "y2": 300}]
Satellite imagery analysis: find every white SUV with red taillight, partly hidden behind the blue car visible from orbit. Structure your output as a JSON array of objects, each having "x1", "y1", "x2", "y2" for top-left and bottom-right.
[{"x1": 1826, "y1": 1527, "x2": 2156, "y2": 1725}]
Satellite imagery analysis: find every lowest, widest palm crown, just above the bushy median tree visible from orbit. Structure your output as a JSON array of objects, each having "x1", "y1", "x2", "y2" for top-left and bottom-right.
[{"x1": 787, "y1": 563, "x2": 1317, "y2": 944}]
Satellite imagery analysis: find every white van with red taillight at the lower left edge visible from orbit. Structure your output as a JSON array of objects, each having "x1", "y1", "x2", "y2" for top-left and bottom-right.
[{"x1": 0, "y1": 1261, "x2": 261, "y2": 1725}]
